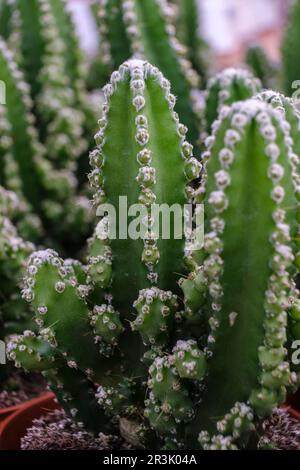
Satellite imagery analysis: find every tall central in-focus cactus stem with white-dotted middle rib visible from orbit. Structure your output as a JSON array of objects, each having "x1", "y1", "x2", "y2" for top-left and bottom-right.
[{"x1": 90, "y1": 60, "x2": 201, "y2": 311}]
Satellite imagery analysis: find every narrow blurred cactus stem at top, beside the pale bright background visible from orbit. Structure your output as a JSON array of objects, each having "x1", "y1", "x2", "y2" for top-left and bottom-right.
[{"x1": 174, "y1": 0, "x2": 209, "y2": 88}]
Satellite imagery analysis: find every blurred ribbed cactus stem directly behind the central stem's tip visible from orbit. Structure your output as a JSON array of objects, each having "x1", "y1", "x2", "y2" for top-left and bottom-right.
[{"x1": 99, "y1": 0, "x2": 199, "y2": 143}]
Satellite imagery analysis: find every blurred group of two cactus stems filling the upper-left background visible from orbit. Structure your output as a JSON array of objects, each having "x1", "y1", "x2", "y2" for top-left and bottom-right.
[{"x1": 0, "y1": 0, "x2": 98, "y2": 253}]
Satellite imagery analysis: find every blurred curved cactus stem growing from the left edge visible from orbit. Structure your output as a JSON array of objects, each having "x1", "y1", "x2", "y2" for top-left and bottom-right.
[{"x1": 0, "y1": 41, "x2": 85, "y2": 226}]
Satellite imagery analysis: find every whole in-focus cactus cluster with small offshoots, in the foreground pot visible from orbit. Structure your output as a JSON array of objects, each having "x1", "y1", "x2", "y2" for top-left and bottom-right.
[{"x1": 8, "y1": 54, "x2": 299, "y2": 449}]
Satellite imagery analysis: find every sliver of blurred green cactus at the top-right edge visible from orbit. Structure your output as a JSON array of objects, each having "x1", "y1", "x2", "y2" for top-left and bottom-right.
[{"x1": 282, "y1": 0, "x2": 300, "y2": 96}]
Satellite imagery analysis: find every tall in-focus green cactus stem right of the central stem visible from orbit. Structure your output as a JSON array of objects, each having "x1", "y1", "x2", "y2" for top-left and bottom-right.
[{"x1": 186, "y1": 100, "x2": 299, "y2": 445}]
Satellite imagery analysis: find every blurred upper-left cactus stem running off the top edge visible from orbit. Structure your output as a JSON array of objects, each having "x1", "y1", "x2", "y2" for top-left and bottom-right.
[{"x1": 1, "y1": 0, "x2": 85, "y2": 166}]
